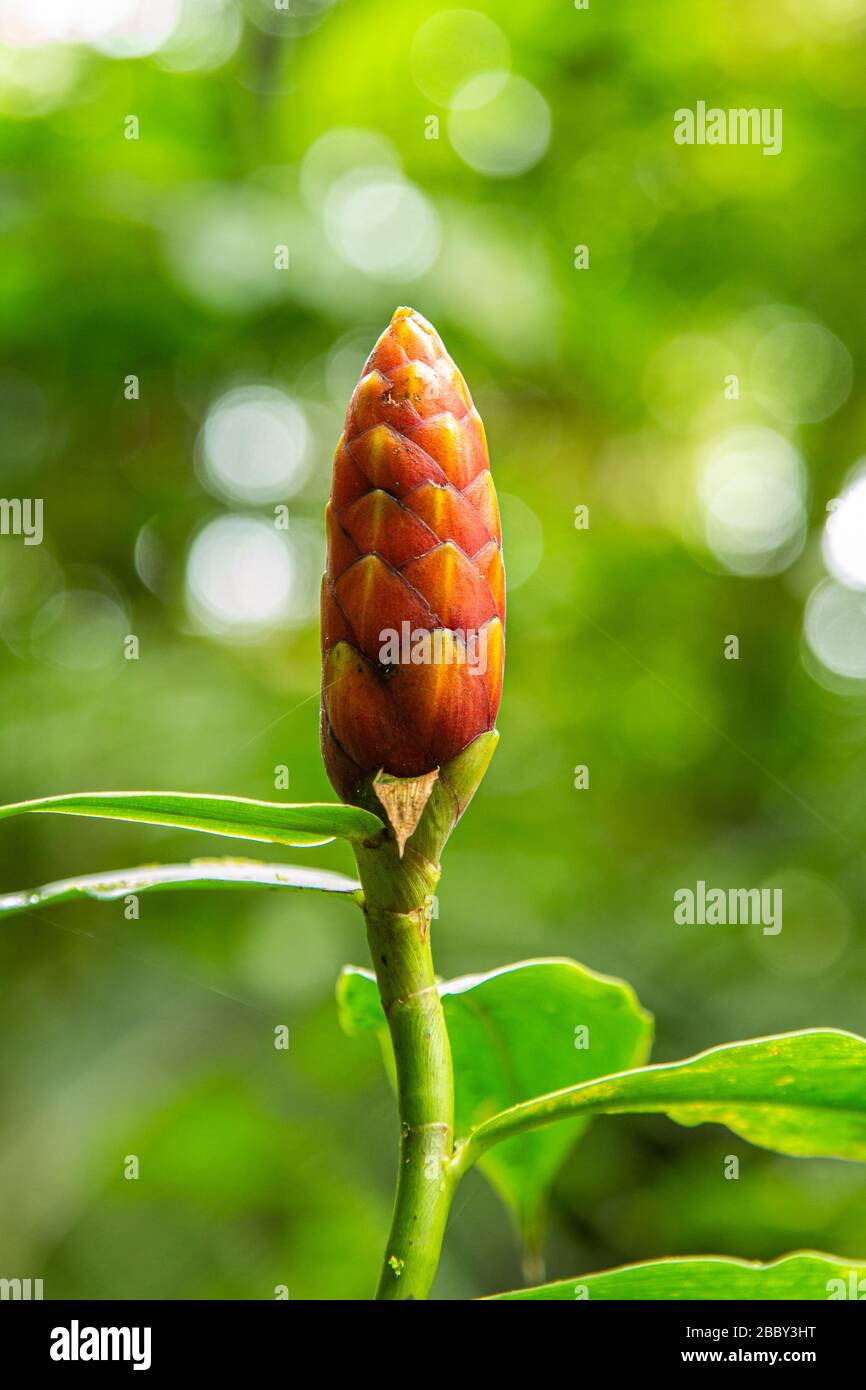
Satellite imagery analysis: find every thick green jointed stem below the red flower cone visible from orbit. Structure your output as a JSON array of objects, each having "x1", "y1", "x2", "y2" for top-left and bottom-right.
[{"x1": 357, "y1": 842, "x2": 455, "y2": 1300}]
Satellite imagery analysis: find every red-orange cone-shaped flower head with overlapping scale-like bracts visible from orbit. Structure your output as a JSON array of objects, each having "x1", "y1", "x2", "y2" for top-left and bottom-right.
[{"x1": 321, "y1": 309, "x2": 505, "y2": 801}]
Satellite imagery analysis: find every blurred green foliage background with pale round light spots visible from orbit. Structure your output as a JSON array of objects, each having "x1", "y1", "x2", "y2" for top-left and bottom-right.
[{"x1": 0, "y1": 0, "x2": 866, "y2": 1298}]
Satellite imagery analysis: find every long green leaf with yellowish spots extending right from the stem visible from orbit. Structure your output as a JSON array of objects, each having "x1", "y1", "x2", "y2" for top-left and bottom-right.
[{"x1": 460, "y1": 1029, "x2": 866, "y2": 1168}]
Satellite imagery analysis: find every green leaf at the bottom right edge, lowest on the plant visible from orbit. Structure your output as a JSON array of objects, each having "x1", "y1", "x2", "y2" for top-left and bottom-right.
[{"x1": 484, "y1": 1251, "x2": 866, "y2": 1302}]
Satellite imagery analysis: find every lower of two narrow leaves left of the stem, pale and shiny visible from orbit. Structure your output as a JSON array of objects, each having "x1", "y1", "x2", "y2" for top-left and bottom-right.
[{"x1": 0, "y1": 859, "x2": 360, "y2": 917}]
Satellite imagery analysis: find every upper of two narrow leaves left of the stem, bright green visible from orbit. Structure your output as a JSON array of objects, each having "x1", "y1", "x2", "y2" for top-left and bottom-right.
[{"x1": 0, "y1": 791, "x2": 385, "y2": 845}]
